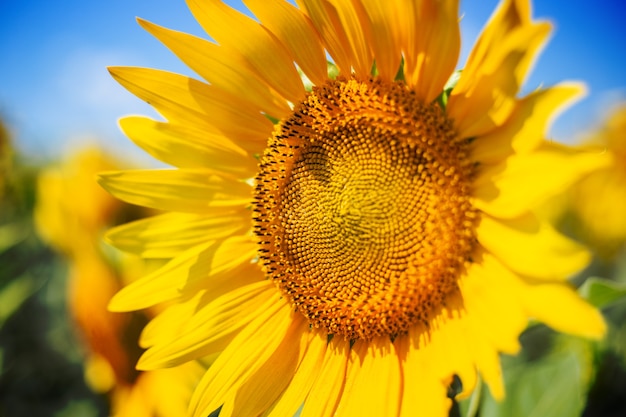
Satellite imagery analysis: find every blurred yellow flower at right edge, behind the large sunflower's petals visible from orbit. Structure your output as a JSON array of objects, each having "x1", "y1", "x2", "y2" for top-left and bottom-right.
[{"x1": 572, "y1": 104, "x2": 626, "y2": 257}]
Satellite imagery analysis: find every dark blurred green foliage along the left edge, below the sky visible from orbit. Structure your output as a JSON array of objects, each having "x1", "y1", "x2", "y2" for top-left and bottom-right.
[{"x1": 0, "y1": 142, "x2": 108, "y2": 417}]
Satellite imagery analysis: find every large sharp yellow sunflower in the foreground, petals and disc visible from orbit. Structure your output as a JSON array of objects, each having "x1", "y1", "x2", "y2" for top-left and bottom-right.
[{"x1": 100, "y1": 0, "x2": 607, "y2": 417}]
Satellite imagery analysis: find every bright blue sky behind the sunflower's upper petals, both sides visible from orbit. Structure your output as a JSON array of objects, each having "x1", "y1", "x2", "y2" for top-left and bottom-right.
[{"x1": 0, "y1": 0, "x2": 626, "y2": 163}]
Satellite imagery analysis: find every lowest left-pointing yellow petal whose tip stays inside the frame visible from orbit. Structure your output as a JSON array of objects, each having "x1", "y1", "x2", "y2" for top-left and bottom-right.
[{"x1": 137, "y1": 280, "x2": 279, "y2": 370}]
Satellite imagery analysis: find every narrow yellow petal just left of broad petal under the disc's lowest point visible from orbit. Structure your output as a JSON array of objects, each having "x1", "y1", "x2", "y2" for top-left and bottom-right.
[{"x1": 300, "y1": 338, "x2": 350, "y2": 417}]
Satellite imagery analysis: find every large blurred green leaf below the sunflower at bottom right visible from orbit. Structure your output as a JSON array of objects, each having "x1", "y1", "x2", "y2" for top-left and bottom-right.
[{"x1": 480, "y1": 351, "x2": 587, "y2": 417}]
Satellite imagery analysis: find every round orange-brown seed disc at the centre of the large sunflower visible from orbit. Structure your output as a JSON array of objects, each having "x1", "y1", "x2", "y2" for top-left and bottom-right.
[{"x1": 255, "y1": 79, "x2": 476, "y2": 339}]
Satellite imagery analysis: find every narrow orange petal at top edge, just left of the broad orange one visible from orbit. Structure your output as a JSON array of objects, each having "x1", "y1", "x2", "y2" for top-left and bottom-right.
[{"x1": 361, "y1": 0, "x2": 405, "y2": 81}]
